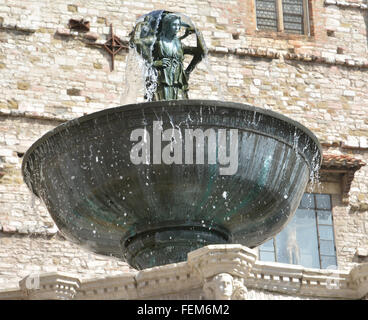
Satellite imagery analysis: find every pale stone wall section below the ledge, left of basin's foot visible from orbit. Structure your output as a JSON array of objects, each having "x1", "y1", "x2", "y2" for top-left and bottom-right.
[{"x1": 0, "y1": 232, "x2": 131, "y2": 289}]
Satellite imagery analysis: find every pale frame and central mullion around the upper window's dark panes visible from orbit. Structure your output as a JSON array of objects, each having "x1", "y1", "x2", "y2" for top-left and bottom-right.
[{"x1": 254, "y1": 0, "x2": 311, "y2": 37}]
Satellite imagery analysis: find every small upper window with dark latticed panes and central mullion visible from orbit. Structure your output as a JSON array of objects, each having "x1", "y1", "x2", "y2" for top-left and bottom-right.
[{"x1": 255, "y1": 0, "x2": 310, "y2": 35}]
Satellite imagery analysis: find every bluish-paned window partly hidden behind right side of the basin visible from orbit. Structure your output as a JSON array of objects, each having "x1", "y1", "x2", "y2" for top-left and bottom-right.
[{"x1": 258, "y1": 193, "x2": 337, "y2": 269}]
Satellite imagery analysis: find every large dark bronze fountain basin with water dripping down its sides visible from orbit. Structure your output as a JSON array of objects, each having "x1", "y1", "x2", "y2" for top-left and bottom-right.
[{"x1": 22, "y1": 100, "x2": 321, "y2": 269}]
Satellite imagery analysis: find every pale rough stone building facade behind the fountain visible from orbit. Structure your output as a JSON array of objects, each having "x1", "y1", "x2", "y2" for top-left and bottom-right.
[{"x1": 0, "y1": 0, "x2": 368, "y2": 298}]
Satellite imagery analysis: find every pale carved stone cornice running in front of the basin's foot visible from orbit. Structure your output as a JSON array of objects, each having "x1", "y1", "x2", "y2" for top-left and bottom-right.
[{"x1": 0, "y1": 245, "x2": 368, "y2": 300}]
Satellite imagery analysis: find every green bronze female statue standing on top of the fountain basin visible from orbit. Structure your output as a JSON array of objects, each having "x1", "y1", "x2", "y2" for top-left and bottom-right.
[{"x1": 130, "y1": 11, "x2": 206, "y2": 101}]
